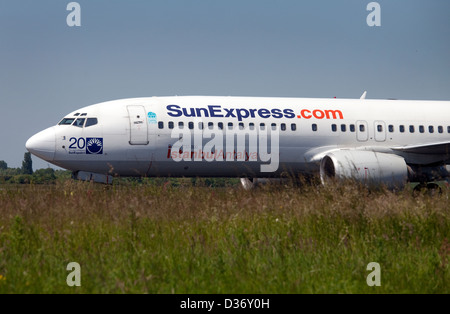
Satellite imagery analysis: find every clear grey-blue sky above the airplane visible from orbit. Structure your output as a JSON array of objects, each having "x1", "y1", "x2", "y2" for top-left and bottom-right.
[{"x1": 0, "y1": 0, "x2": 450, "y2": 169}]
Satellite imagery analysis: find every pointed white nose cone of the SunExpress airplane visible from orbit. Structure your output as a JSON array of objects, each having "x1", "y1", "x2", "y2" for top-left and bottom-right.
[{"x1": 25, "y1": 127, "x2": 56, "y2": 161}]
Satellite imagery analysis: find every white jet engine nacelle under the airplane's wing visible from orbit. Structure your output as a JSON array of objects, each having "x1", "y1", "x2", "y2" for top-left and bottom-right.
[{"x1": 320, "y1": 150, "x2": 408, "y2": 189}]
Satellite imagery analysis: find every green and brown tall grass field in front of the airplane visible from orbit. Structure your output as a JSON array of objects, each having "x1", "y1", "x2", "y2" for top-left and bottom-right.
[{"x1": 0, "y1": 181, "x2": 450, "y2": 294}]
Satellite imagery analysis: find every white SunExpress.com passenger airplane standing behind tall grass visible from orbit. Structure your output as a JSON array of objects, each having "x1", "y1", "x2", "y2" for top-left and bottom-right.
[{"x1": 26, "y1": 93, "x2": 450, "y2": 188}]
